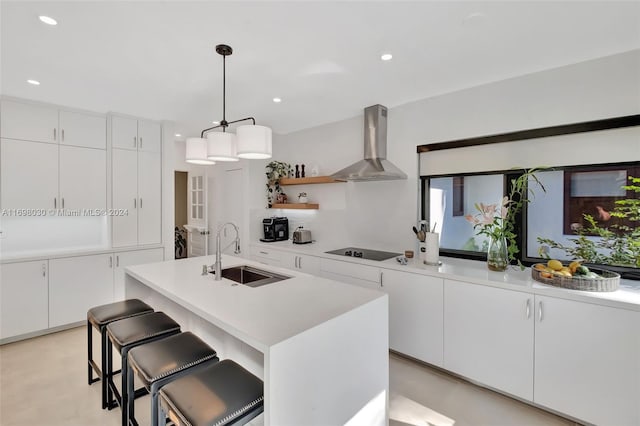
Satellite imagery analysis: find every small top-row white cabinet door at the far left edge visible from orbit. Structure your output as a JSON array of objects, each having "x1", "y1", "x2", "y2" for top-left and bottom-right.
[{"x1": 0, "y1": 100, "x2": 58, "y2": 143}]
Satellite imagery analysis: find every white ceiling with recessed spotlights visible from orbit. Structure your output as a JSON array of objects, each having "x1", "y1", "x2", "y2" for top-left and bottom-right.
[{"x1": 0, "y1": 0, "x2": 640, "y2": 135}]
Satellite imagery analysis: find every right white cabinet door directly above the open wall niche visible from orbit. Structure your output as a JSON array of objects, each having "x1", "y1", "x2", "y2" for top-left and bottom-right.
[{"x1": 60, "y1": 146, "x2": 107, "y2": 209}]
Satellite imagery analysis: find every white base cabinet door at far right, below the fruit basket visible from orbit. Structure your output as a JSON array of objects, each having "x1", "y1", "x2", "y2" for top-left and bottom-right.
[{"x1": 534, "y1": 296, "x2": 640, "y2": 426}]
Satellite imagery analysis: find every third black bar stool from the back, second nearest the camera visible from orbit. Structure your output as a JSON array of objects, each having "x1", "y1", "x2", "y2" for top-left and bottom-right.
[{"x1": 127, "y1": 331, "x2": 218, "y2": 426}]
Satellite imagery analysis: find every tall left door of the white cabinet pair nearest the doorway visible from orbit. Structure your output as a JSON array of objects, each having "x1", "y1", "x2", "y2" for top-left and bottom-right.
[{"x1": 111, "y1": 149, "x2": 138, "y2": 247}]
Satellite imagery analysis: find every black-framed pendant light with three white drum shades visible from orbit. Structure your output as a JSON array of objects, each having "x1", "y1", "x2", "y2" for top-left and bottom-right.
[{"x1": 187, "y1": 44, "x2": 271, "y2": 164}]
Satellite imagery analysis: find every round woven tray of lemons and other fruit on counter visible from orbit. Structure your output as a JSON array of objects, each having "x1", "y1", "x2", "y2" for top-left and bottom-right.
[{"x1": 531, "y1": 259, "x2": 620, "y2": 291}]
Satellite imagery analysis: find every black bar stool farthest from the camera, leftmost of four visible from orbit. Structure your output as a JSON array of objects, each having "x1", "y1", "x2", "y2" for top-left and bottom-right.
[{"x1": 87, "y1": 299, "x2": 153, "y2": 408}]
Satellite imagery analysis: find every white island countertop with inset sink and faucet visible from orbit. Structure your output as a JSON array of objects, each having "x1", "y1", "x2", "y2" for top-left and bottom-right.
[{"x1": 126, "y1": 255, "x2": 387, "y2": 353}]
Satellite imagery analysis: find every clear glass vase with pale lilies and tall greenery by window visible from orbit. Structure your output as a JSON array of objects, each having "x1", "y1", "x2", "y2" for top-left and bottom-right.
[{"x1": 465, "y1": 168, "x2": 546, "y2": 271}]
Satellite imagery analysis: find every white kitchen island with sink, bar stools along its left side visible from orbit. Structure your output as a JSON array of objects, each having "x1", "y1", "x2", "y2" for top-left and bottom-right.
[{"x1": 126, "y1": 256, "x2": 389, "y2": 426}]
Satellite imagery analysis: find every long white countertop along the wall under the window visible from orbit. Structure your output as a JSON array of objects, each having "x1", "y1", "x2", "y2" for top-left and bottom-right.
[{"x1": 252, "y1": 241, "x2": 640, "y2": 311}]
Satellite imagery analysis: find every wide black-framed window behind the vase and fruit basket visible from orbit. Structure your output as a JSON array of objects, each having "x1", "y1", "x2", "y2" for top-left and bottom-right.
[{"x1": 422, "y1": 162, "x2": 640, "y2": 278}]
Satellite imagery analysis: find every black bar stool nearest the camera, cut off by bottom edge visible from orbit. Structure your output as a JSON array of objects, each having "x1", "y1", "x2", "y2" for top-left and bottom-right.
[{"x1": 158, "y1": 359, "x2": 264, "y2": 426}]
